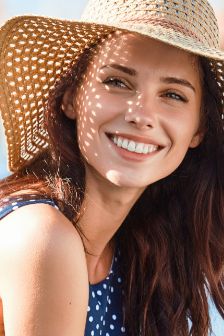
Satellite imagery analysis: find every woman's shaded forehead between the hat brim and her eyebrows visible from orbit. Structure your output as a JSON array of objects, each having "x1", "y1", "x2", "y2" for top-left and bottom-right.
[{"x1": 93, "y1": 31, "x2": 199, "y2": 77}]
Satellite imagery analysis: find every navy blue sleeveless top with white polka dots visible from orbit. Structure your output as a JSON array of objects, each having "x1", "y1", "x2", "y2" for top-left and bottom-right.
[{"x1": 0, "y1": 195, "x2": 127, "y2": 336}]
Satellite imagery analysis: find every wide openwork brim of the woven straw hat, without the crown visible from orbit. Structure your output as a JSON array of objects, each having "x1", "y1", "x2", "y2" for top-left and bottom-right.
[{"x1": 0, "y1": 16, "x2": 224, "y2": 171}]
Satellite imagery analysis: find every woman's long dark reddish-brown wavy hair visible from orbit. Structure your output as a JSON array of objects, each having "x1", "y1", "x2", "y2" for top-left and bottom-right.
[{"x1": 0, "y1": 38, "x2": 224, "y2": 336}]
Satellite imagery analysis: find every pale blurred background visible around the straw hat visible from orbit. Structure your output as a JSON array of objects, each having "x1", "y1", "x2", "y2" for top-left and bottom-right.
[{"x1": 0, "y1": 0, "x2": 224, "y2": 178}]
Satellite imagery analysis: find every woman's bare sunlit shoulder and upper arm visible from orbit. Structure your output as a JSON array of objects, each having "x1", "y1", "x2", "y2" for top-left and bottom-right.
[{"x1": 0, "y1": 204, "x2": 89, "y2": 336}]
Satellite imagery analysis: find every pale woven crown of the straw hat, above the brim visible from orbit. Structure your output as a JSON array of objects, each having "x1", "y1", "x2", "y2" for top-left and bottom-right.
[{"x1": 82, "y1": 0, "x2": 219, "y2": 48}]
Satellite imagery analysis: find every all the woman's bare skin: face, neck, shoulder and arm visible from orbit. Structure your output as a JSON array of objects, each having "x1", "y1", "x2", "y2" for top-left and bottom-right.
[{"x1": 0, "y1": 33, "x2": 202, "y2": 336}]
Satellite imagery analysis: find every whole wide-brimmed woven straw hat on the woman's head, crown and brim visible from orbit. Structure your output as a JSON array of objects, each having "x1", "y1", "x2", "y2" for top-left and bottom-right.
[{"x1": 0, "y1": 0, "x2": 224, "y2": 171}]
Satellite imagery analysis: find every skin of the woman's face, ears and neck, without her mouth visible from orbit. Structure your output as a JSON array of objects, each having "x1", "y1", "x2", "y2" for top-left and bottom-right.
[{"x1": 63, "y1": 33, "x2": 202, "y2": 282}]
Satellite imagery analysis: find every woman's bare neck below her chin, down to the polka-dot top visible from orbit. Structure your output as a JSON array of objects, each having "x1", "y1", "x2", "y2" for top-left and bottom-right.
[{"x1": 78, "y1": 168, "x2": 143, "y2": 277}]
